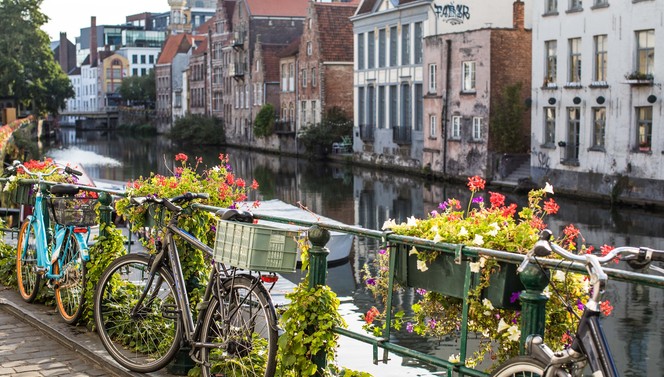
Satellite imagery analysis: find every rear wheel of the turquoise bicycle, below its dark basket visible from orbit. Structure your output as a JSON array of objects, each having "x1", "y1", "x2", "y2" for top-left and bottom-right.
[{"x1": 53, "y1": 233, "x2": 87, "y2": 325}]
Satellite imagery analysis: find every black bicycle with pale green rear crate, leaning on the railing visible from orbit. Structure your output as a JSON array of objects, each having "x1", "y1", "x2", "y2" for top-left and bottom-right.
[{"x1": 94, "y1": 193, "x2": 296, "y2": 377}]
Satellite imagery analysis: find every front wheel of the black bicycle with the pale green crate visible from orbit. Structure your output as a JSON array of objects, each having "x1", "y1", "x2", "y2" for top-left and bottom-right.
[{"x1": 94, "y1": 254, "x2": 182, "y2": 373}]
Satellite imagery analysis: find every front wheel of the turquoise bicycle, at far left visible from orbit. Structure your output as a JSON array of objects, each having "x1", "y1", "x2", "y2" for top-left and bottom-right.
[{"x1": 16, "y1": 221, "x2": 42, "y2": 302}]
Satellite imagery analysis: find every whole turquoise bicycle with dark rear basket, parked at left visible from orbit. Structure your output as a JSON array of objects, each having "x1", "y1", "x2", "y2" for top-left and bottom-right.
[{"x1": 8, "y1": 161, "x2": 97, "y2": 324}]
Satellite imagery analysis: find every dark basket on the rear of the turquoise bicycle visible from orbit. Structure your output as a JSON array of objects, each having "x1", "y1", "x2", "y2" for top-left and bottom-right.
[{"x1": 50, "y1": 197, "x2": 99, "y2": 227}]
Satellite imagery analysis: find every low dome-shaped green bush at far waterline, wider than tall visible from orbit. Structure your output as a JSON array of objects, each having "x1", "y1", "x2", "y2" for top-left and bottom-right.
[{"x1": 168, "y1": 114, "x2": 226, "y2": 145}]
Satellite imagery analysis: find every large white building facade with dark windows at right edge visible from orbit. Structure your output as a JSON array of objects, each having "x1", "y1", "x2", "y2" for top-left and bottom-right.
[{"x1": 531, "y1": 0, "x2": 664, "y2": 201}]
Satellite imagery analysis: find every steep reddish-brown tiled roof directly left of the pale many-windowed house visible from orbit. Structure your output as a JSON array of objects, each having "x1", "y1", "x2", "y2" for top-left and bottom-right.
[{"x1": 312, "y1": 3, "x2": 357, "y2": 62}]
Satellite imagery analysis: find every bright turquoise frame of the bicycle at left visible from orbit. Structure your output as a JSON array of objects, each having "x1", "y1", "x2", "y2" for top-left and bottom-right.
[{"x1": 21, "y1": 188, "x2": 90, "y2": 280}]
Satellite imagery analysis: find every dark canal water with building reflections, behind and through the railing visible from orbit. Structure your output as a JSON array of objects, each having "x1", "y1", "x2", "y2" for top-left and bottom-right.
[{"x1": 47, "y1": 129, "x2": 664, "y2": 377}]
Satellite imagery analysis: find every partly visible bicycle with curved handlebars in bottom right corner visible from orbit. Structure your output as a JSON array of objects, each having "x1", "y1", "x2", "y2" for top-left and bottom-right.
[{"x1": 492, "y1": 230, "x2": 664, "y2": 377}]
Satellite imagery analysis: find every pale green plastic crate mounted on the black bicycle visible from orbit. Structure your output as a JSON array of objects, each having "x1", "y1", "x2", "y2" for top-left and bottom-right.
[{"x1": 214, "y1": 220, "x2": 298, "y2": 272}]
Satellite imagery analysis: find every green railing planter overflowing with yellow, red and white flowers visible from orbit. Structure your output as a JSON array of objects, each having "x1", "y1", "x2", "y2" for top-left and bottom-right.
[{"x1": 364, "y1": 177, "x2": 611, "y2": 367}]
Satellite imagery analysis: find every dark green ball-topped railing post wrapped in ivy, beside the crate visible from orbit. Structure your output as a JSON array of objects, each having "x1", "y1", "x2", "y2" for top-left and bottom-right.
[{"x1": 309, "y1": 225, "x2": 330, "y2": 376}]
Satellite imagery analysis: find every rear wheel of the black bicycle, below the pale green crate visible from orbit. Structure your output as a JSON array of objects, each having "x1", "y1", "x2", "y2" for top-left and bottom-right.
[{"x1": 201, "y1": 275, "x2": 277, "y2": 377}]
